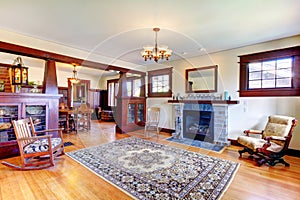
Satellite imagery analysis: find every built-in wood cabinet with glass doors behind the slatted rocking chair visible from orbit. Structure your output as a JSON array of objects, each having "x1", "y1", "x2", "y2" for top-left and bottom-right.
[{"x1": 0, "y1": 93, "x2": 61, "y2": 158}]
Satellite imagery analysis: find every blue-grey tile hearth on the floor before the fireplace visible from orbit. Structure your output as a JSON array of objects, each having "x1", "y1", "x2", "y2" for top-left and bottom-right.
[{"x1": 167, "y1": 137, "x2": 225, "y2": 153}]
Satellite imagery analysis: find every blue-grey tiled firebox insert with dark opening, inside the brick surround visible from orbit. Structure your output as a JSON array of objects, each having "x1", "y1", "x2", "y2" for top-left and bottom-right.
[{"x1": 183, "y1": 104, "x2": 214, "y2": 143}]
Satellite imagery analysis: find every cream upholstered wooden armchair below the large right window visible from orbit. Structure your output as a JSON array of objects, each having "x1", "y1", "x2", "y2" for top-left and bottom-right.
[{"x1": 237, "y1": 115, "x2": 297, "y2": 167}]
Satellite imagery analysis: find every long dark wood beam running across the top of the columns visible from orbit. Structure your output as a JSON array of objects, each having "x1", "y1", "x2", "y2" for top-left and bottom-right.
[{"x1": 0, "y1": 41, "x2": 146, "y2": 76}]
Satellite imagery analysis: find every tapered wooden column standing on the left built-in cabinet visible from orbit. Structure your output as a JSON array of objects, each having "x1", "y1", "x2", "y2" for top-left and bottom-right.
[{"x1": 43, "y1": 60, "x2": 58, "y2": 94}]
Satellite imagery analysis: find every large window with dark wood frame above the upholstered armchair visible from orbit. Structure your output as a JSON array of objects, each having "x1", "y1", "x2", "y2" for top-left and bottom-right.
[{"x1": 239, "y1": 46, "x2": 300, "y2": 97}]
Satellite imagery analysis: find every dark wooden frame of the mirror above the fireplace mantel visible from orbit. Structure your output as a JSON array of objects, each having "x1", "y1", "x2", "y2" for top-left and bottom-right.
[{"x1": 185, "y1": 65, "x2": 218, "y2": 93}]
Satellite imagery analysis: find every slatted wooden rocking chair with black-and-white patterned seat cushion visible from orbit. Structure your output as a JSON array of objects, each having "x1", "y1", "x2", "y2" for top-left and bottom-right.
[{"x1": 2, "y1": 118, "x2": 64, "y2": 170}]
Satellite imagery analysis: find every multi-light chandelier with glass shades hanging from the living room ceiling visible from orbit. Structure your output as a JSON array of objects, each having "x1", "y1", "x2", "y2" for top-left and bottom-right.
[{"x1": 141, "y1": 28, "x2": 172, "y2": 62}]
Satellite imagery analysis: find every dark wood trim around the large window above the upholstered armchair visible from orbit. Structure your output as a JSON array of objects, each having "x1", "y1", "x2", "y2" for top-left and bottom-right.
[{"x1": 239, "y1": 46, "x2": 300, "y2": 97}]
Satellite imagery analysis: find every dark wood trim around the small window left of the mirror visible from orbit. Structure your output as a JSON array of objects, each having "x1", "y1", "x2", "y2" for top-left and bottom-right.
[{"x1": 148, "y1": 67, "x2": 173, "y2": 97}]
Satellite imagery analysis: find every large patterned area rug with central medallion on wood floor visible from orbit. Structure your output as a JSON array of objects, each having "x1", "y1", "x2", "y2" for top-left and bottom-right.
[{"x1": 67, "y1": 137, "x2": 239, "y2": 199}]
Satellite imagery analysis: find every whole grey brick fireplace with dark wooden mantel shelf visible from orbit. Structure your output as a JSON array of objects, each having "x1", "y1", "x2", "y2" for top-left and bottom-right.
[{"x1": 168, "y1": 99, "x2": 239, "y2": 145}]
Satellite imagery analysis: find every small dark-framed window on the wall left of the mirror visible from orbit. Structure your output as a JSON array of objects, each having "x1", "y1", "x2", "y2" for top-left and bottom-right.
[{"x1": 148, "y1": 68, "x2": 172, "y2": 97}]
